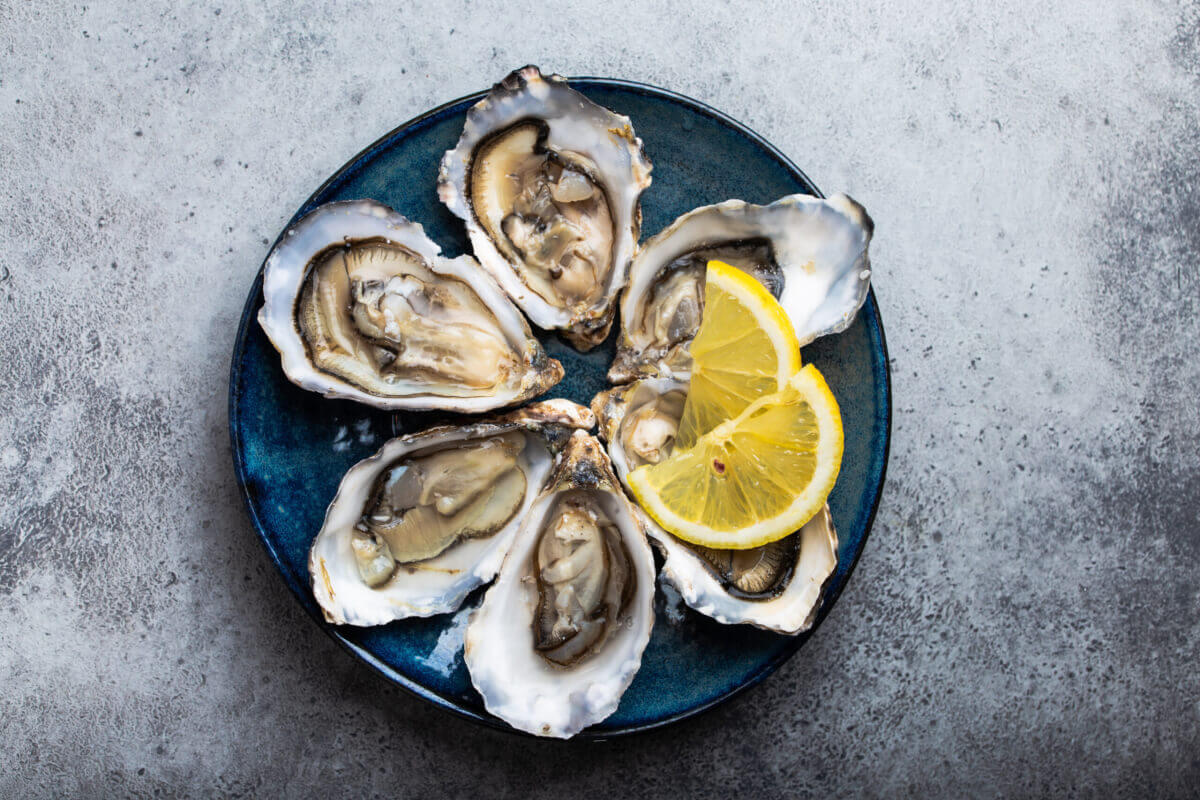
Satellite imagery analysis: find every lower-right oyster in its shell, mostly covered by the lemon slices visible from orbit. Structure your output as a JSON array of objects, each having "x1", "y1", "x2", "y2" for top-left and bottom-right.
[{"x1": 592, "y1": 378, "x2": 838, "y2": 633}]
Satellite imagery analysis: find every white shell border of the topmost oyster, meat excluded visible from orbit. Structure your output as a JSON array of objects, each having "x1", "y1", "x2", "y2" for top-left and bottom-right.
[{"x1": 438, "y1": 66, "x2": 650, "y2": 347}]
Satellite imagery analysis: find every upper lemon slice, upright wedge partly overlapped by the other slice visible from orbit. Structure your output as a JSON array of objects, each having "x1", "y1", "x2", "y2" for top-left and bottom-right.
[{"x1": 676, "y1": 261, "x2": 800, "y2": 447}]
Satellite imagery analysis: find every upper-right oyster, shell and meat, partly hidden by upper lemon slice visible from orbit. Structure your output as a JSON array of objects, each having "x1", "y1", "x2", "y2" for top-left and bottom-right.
[{"x1": 608, "y1": 194, "x2": 875, "y2": 383}]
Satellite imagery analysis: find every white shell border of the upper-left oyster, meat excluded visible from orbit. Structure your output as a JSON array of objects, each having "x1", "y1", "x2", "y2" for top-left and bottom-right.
[{"x1": 258, "y1": 200, "x2": 563, "y2": 411}]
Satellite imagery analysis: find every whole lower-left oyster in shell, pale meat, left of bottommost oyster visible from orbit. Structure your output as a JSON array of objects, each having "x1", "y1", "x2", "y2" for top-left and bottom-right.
[{"x1": 308, "y1": 399, "x2": 595, "y2": 625}]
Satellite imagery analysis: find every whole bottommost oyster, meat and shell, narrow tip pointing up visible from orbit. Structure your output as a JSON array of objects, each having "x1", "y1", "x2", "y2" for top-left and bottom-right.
[{"x1": 463, "y1": 431, "x2": 654, "y2": 739}]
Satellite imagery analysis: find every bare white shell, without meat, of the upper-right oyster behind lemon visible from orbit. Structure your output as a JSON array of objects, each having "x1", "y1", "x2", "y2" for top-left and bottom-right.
[{"x1": 608, "y1": 194, "x2": 875, "y2": 383}]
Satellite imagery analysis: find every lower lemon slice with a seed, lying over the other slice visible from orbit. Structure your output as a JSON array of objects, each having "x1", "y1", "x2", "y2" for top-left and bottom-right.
[{"x1": 629, "y1": 365, "x2": 842, "y2": 549}]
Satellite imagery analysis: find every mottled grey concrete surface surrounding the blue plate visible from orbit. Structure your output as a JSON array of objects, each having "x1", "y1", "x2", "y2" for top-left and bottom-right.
[{"x1": 0, "y1": 0, "x2": 1200, "y2": 798}]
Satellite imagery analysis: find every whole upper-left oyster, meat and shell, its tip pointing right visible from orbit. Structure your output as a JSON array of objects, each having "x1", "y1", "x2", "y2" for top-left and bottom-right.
[{"x1": 258, "y1": 200, "x2": 563, "y2": 411}]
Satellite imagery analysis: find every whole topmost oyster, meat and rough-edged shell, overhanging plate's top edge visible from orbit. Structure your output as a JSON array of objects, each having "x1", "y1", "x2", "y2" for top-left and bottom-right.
[{"x1": 438, "y1": 66, "x2": 650, "y2": 350}]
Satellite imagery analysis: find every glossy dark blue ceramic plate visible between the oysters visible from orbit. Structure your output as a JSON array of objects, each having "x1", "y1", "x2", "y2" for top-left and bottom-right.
[{"x1": 229, "y1": 78, "x2": 890, "y2": 738}]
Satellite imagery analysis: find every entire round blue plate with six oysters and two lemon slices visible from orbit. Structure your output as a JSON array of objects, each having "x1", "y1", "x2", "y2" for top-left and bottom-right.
[{"x1": 230, "y1": 66, "x2": 889, "y2": 739}]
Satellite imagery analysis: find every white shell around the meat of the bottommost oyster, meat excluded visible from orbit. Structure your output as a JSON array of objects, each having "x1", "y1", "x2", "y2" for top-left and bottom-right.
[{"x1": 463, "y1": 431, "x2": 654, "y2": 739}]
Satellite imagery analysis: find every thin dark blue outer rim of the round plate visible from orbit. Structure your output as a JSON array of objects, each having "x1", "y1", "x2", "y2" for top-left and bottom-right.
[{"x1": 228, "y1": 76, "x2": 892, "y2": 741}]
